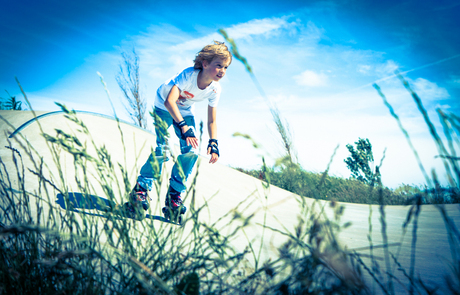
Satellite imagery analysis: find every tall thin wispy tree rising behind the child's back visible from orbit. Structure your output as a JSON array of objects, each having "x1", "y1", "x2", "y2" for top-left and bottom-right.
[{"x1": 116, "y1": 48, "x2": 147, "y2": 128}]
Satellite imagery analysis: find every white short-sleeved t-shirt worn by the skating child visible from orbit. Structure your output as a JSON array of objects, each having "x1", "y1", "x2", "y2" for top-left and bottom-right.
[{"x1": 155, "y1": 67, "x2": 221, "y2": 116}]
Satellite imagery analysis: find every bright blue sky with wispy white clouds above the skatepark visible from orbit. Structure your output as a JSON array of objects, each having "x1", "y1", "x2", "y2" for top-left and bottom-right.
[{"x1": 0, "y1": 0, "x2": 460, "y2": 187}]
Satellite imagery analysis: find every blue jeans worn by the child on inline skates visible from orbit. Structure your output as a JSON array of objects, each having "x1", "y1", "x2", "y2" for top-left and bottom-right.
[{"x1": 137, "y1": 108, "x2": 198, "y2": 193}]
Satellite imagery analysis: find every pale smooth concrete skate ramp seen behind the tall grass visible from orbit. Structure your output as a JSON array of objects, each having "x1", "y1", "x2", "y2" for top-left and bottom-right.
[{"x1": 0, "y1": 111, "x2": 460, "y2": 293}]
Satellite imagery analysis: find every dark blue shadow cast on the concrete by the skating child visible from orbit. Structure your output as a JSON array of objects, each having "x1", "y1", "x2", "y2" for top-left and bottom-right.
[{"x1": 56, "y1": 192, "x2": 175, "y2": 224}]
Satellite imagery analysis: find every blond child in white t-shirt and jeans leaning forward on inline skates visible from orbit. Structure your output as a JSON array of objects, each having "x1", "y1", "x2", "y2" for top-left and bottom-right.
[{"x1": 127, "y1": 41, "x2": 232, "y2": 221}]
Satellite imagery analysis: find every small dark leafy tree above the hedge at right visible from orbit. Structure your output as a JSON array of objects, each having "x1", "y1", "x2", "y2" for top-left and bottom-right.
[{"x1": 344, "y1": 138, "x2": 381, "y2": 186}]
